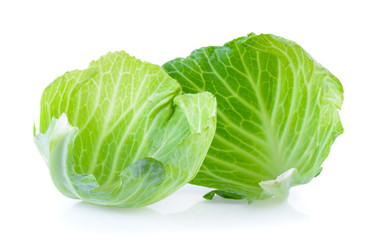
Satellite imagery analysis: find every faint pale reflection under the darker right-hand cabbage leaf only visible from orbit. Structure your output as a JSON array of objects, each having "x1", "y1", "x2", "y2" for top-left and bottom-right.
[{"x1": 169, "y1": 198, "x2": 308, "y2": 231}]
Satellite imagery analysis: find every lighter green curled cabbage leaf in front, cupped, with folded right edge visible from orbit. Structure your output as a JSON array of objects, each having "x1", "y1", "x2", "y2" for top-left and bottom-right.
[{"x1": 35, "y1": 52, "x2": 216, "y2": 207}]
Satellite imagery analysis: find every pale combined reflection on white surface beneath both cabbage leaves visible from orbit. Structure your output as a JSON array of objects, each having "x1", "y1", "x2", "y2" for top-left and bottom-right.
[{"x1": 61, "y1": 185, "x2": 308, "y2": 235}]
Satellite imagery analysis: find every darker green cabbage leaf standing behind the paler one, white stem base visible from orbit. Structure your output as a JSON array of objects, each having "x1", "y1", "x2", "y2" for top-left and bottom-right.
[{"x1": 163, "y1": 34, "x2": 343, "y2": 201}]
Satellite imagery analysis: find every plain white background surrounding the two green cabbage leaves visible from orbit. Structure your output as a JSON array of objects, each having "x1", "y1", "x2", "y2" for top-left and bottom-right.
[{"x1": 0, "y1": 0, "x2": 381, "y2": 239}]
